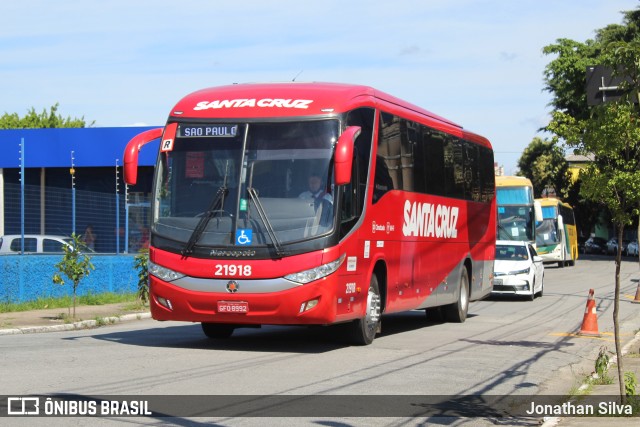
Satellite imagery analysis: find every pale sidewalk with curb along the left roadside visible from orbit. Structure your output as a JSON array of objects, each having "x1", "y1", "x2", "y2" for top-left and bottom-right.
[{"x1": 0, "y1": 303, "x2": 151, "y2": 335}]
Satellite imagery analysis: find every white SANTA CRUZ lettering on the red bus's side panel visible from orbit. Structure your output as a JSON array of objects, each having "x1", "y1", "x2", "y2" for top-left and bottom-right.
[{"x1": 402, "y1": 200, "x2": 459, "y2": 239}]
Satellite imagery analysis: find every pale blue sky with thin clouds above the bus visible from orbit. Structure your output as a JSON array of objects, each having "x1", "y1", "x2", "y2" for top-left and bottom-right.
[{"x1": 0, "y1": 0, "x2": 640, "y2": 174}]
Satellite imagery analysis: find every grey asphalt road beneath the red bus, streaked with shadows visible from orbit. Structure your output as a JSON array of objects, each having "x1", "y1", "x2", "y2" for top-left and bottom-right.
[{"x1": 0, "y1": 256, "x2": 640, "y2": 425}]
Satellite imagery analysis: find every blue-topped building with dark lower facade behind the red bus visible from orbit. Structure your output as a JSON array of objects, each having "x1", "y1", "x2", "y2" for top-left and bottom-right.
[{"x1": 0, "y1": 126, "x2": 158, "y2": 253}]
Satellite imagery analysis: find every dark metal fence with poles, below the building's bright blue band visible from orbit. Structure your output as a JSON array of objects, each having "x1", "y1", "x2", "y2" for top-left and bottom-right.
[{"x1": 4, "y1": 183, "x2": 150, "y2": 253}]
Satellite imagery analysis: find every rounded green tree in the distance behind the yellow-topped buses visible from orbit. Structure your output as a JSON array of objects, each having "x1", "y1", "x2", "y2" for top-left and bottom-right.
[{"x1": 518, "y1": 137, "x2": 571, "y2": 199}]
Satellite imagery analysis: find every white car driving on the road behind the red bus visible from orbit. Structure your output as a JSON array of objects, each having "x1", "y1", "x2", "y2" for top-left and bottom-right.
[{"x1": 492, "y1": 240, "x2": 544, "y2": 301}]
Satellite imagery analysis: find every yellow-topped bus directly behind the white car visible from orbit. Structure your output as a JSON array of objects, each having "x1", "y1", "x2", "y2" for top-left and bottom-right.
[{"x1": 496, "y1": 176, "x2": 540, "y2": 245}]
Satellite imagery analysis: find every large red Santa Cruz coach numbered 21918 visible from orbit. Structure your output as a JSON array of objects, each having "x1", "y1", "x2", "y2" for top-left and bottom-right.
[{"x1": 124, "y1": 83, "x2": 496, "y2": 344}]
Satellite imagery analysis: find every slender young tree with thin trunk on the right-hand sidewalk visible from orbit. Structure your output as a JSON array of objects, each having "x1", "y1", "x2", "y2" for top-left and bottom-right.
[{"x1": 548, "y1": 41, "x2": 640, "y2": 403}]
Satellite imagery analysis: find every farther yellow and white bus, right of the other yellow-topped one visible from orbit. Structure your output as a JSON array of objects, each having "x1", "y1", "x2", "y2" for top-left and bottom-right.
[{"x1": 536, "y1": 197, "x2": 578, "y2": 267}]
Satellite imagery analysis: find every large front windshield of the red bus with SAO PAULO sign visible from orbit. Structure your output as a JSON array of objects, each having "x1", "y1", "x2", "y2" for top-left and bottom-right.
[{"x1": 152, "y1": 119, "x2": 339, "y2": 252}]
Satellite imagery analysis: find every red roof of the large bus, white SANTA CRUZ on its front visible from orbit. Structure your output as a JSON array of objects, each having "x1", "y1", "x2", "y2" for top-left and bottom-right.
[{"x1": 170, "y1": 82, "x2": 491, "y2": 147}]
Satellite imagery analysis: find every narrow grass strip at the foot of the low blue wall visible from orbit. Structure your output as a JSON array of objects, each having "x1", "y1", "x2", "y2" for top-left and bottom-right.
[{"x1": 0, "y1": 292, "x2": 143, "y2": 313}]
